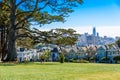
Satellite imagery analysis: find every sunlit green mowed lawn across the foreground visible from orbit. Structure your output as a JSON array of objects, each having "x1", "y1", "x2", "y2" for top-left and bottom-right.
[{"x1": 0, "y1": 62, "x2": 120, "y2": 80}]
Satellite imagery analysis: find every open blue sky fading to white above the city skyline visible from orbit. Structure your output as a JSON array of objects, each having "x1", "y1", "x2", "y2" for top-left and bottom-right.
[{"x1": 40, "y1": 0, "x2": 120, "y2": 37}]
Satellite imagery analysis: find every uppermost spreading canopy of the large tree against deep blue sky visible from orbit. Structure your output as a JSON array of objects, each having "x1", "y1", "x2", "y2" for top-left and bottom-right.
[{"x1": 0, "y1": 0, "x2": 82, "y2": 26}]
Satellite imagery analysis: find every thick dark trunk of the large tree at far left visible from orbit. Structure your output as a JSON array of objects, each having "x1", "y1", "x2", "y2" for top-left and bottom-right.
[{"x1": 6, "y1": 0, "x2": 17, "y2": 61}]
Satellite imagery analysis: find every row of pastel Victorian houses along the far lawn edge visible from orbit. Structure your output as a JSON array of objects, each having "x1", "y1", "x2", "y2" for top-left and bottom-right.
[{"x1": 18, "y1": 45, "x2": 120, "y2": 63}]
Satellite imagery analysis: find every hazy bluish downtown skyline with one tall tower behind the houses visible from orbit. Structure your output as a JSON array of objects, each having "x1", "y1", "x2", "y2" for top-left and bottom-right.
[{"x1": 76, "y1": 27, "x2": 116, "y2": 46}]
